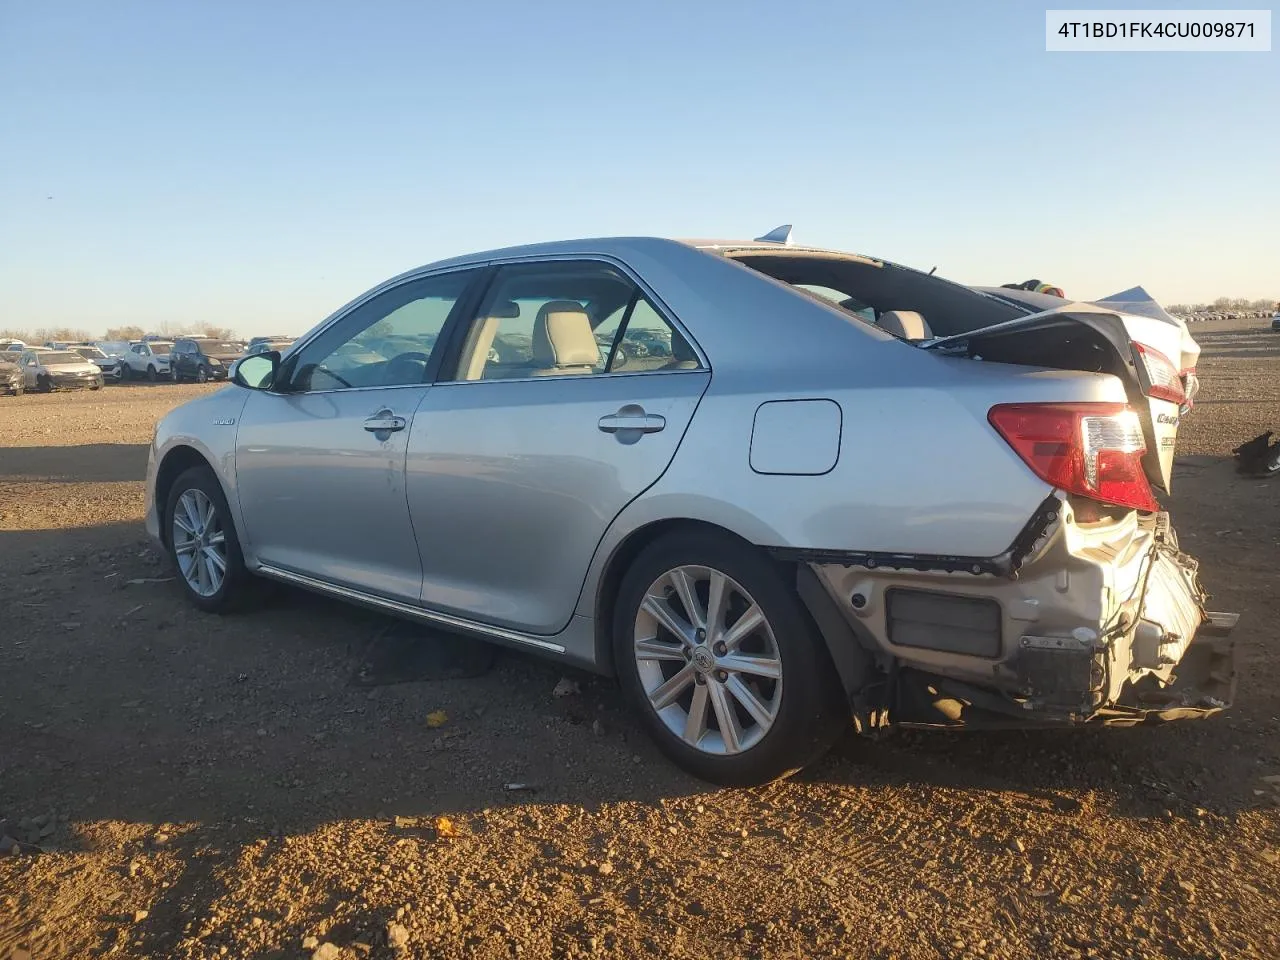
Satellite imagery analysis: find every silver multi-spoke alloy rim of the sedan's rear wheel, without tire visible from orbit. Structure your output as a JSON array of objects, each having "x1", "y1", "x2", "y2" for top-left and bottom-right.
[{"x1": 632, "y1": 566, "x2": 782, "y2": 755}]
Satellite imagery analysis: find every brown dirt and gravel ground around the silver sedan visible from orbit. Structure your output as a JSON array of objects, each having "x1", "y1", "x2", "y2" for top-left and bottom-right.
[{"x1": 0, "y1": 320, "x2": 1280, "y2": 960}]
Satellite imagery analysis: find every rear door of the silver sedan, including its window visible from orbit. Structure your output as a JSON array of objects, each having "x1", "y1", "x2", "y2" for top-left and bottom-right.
[{"x1": 406, "y1": 260, "x2": 710, "y2": 635}]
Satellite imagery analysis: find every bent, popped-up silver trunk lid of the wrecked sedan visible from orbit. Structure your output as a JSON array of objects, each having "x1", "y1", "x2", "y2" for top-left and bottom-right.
[{"x1": 920, "y1": 303, "x2": 1194, "y2": 493}]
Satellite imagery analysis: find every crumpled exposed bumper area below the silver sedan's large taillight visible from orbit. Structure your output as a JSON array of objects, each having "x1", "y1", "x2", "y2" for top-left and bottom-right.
[{"x1": 813, "y1": 500, "x2": 1236, "y2": 727}]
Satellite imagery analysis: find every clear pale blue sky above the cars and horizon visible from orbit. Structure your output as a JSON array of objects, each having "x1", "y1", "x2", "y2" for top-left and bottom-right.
[{"x1": 0, "y1": 0, "x2": 1280, "y2": 334}]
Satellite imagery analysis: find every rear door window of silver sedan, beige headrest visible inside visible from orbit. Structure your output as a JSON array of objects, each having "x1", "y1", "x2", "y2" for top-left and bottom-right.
[{"x1": 451, "y1": 261, "x2": 696, "y2": 380}]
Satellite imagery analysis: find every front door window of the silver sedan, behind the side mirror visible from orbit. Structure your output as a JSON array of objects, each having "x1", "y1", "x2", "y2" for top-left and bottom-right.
[{"x1": 284, "y1": 270, "x2": 477, "y2": 392}]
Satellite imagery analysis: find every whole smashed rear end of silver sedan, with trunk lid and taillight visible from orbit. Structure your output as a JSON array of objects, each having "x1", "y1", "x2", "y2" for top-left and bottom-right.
[{"x1": 812, "y1": 305, "x2": 1235, "y2": 727}]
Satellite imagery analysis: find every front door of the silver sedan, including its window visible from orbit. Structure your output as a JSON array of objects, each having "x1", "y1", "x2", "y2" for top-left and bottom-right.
[{"x1": 236, "y1": 270, "x2": 480, "y2": 603}]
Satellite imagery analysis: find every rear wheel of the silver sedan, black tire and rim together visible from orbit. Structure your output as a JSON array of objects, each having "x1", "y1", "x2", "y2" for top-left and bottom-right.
[{"x1": 613, "y1": 531, "x2": 850, "y2": 786}]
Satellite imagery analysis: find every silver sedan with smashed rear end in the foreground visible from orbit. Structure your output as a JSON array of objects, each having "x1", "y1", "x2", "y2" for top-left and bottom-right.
[{"x1": 146, "y1": 232, "x2": 1234, "y2": 783}]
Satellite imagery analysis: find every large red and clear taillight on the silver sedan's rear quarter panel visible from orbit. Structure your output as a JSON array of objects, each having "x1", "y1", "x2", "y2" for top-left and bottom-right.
[{"x1": 987, "y1": 403, "x2": 1160, "y2": 511}]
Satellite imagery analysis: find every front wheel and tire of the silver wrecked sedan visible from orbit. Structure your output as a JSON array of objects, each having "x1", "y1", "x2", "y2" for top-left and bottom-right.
[{"x1": 161, "y1": 467, "x2": 256, "y2": 613}]
